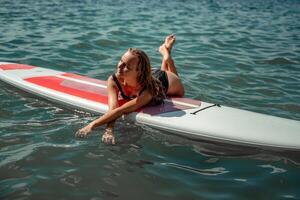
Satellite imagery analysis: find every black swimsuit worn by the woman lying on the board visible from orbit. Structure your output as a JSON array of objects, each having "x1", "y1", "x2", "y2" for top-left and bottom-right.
[{"x1": 112, "y1": 69, "x2": 169, "y2": 100}]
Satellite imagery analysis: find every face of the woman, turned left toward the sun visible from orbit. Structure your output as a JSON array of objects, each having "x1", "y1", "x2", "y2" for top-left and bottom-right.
[{"x1": 117, "y1": 51, "x2": 138, "y2": 79}]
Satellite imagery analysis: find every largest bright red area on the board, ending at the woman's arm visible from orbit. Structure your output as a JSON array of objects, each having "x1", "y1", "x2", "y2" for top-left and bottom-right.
[{"x1": 24, "y1": 76, "x2": 108, "y2": 104}]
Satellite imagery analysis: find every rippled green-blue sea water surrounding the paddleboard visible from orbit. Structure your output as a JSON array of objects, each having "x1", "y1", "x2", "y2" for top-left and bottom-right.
[{"x1": 0, "y1": 0, "x2": 300, "y2": 200}]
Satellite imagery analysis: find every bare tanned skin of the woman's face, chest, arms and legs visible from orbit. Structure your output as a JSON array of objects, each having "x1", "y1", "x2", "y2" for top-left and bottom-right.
[{"x1": 76, "y1": 35, "x2": 184, "y2": 144}]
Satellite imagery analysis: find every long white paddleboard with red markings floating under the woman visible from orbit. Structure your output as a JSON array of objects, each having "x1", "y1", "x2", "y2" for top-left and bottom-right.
[{"x1": 0, "y1": 62, "x2": 300, "y2": 150}]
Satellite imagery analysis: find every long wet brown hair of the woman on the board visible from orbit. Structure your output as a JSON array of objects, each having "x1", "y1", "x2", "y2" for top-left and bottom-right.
[{"x1": 128, "y1": 48, "x2": 166, "y2": 104}]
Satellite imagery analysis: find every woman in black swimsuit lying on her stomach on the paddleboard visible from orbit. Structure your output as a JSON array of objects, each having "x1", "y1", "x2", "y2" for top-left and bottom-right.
[{"x1": 76, "y1": 35, "x2": 184, "y2": 144}]
